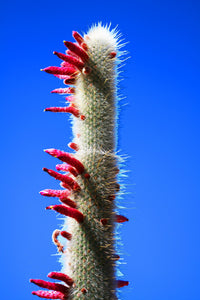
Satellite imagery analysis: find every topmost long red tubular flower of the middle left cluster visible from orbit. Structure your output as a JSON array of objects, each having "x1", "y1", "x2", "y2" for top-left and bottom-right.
[{"x1": 44, "y1": 148, "x2": 85, "y2": 174}]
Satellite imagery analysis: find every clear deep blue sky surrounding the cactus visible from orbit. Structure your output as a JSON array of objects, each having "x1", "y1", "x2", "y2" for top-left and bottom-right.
[{"x1": 0, "y1": 0, "x2": 200, "y2": 300}]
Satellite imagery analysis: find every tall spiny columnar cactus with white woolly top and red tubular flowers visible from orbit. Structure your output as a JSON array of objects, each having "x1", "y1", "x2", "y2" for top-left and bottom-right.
[{"x1": 30, "y1": 24, "x2": 128, "y2": 300}]
